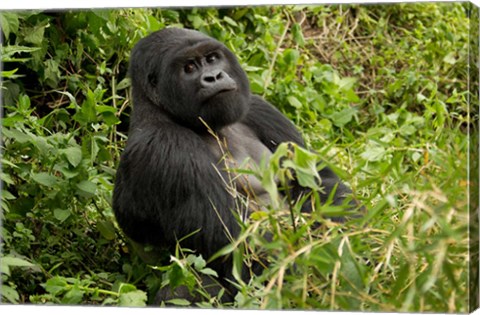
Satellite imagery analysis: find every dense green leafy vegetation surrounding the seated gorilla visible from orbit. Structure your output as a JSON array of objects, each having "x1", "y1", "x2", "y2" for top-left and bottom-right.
[{"x1": 0, "y1": 3, "x2": 478, "y2": 313}]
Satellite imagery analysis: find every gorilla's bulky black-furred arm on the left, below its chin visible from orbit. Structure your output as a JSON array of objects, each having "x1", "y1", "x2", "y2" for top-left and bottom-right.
[{"x1": 113, "y1": 121, "x2": 239, "y2": 258}]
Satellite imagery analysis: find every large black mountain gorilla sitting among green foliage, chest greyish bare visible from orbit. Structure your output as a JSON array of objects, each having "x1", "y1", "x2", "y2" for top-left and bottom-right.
[{"x1": 113, "y1": 28, "x2": 360, "y2": 301}]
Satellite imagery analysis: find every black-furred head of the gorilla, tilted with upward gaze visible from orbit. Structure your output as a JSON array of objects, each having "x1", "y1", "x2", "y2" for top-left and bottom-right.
[{"x1": 130, "y1": 28, "x2": 250, "y2": 130}]
